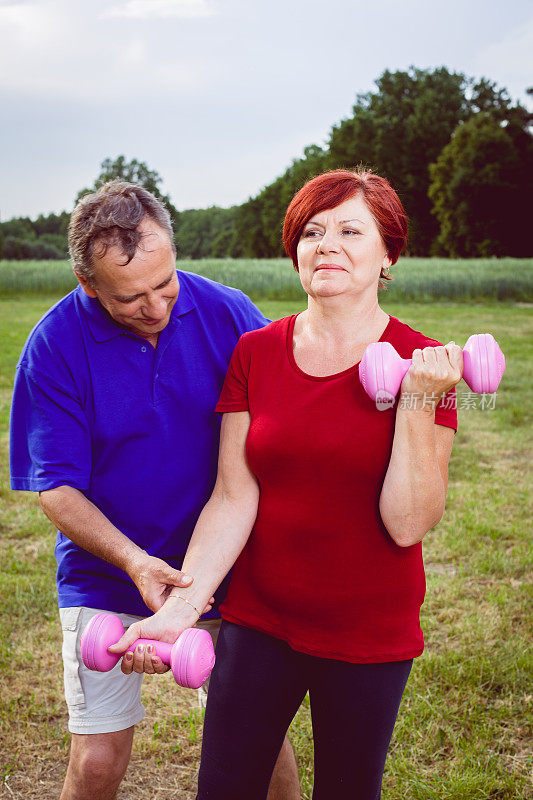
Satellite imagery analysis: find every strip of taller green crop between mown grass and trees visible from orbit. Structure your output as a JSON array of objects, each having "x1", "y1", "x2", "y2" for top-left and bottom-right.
[{"x1": 0, "y1": 258, "x2": 533, "y2": 303}]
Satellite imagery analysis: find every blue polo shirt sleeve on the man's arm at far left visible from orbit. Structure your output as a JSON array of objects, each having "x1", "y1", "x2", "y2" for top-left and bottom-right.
[{"x1": 10, "y1": 365, "x2": 91, "y2": 492}]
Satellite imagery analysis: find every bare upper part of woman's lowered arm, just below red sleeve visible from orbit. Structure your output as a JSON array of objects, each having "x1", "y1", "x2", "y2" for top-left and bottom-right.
[{"x1": 214, "y1": 411, "x2": 259, "y2": 503}]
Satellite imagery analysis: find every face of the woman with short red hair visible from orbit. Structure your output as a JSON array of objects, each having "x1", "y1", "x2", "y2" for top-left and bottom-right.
[{"x1": 297, "y1": 195, "x2": 391, "y2": 298}]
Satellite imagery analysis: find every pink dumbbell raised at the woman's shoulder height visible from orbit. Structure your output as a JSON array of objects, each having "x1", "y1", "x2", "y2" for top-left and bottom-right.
[{"x1": 359, "y1": 333, "x2": 505, "y2": 401}]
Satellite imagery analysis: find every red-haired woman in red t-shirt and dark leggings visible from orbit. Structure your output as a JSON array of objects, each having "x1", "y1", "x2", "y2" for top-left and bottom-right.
[{"x1": 113, "y1": 170, "x2": 462, "y2": 800}]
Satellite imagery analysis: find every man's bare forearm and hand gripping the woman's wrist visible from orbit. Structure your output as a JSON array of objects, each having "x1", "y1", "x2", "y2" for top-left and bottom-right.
[{"x1": 39, "y1": 486, "x2": 192, "y2": 611}]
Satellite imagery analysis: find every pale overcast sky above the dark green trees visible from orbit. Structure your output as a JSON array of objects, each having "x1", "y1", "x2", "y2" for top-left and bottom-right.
[{"x1": 0, "y1": 0, "x2": 533, "y2": 219}]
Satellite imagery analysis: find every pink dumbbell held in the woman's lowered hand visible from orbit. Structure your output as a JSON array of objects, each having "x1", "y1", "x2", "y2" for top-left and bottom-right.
[{"x1": 81, "y1": 611, "x2": 215, "y2": 689}]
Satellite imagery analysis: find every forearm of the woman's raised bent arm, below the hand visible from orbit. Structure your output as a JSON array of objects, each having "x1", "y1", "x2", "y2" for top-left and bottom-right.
[{"x1": 379, "y1": 404, "x2": 446, "y2": 547}]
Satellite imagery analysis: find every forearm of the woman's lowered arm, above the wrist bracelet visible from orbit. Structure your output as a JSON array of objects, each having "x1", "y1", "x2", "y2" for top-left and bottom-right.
[{"x1": 165, "y1": 489, "x2": 259, "y2": 609}]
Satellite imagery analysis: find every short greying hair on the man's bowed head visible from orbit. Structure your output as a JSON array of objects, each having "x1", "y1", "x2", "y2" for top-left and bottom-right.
[{"x1": 68, "y1": 180, "x2": 174, "y2": 286}]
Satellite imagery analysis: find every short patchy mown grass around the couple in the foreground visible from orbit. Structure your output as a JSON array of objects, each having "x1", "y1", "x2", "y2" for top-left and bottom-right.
[{"x1": 0, "y1": 288, "x2": 533, "y2": 800}]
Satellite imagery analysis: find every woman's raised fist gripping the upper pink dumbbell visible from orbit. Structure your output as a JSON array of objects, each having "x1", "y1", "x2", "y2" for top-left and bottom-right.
[{"x1": 400, "y1": 342, "x2": 463, "y2": 411}]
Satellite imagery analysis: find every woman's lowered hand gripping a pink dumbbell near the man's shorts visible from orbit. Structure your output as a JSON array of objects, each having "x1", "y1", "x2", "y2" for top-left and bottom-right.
[{"x1": 109, "y1": 596, "x2": 215, "y2": 675}]
